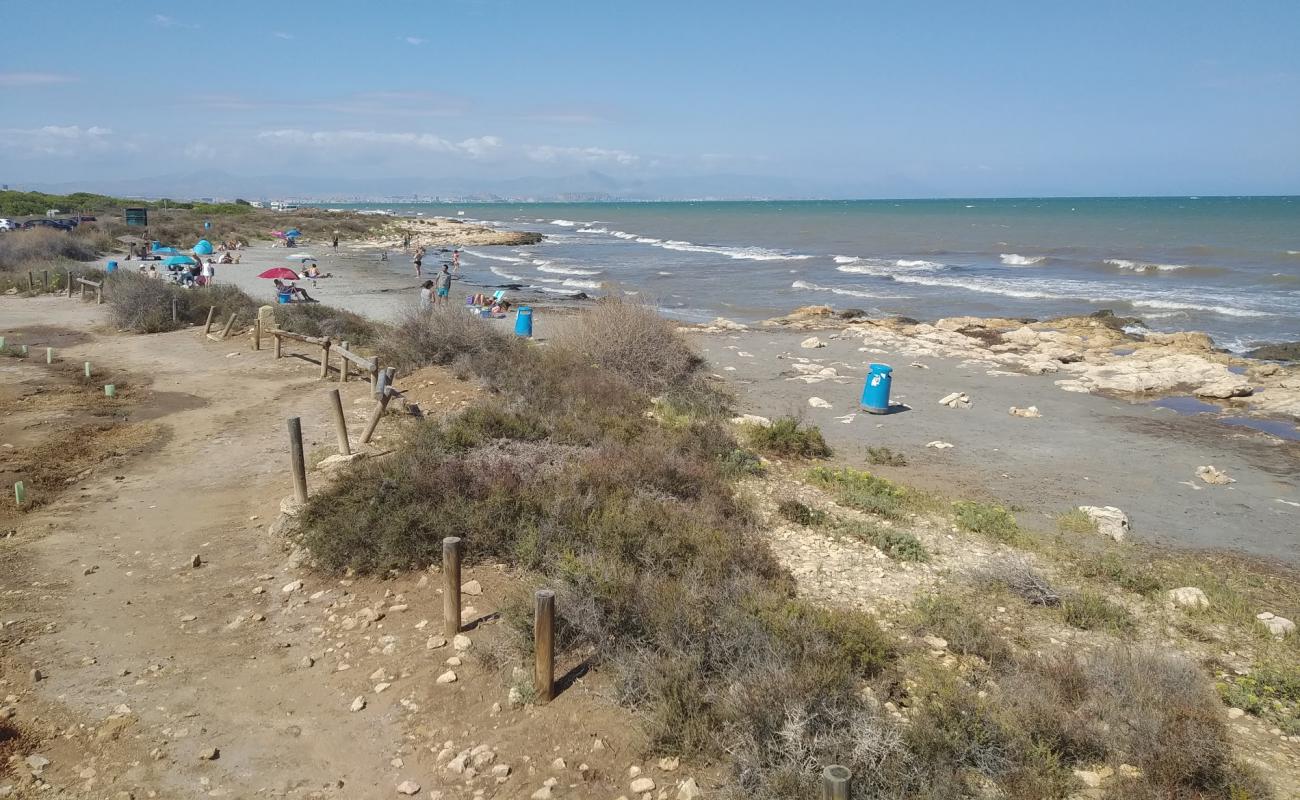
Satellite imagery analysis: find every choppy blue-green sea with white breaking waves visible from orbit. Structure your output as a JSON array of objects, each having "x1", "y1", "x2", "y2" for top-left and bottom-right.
[{"x1": 338, "y1": 196, "x2": 1300, "y2": 351}]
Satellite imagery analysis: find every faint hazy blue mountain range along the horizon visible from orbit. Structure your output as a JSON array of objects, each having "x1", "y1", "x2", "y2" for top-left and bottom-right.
[{"x1": 23, "y1": 169, "x2": 923, "y2": 203}]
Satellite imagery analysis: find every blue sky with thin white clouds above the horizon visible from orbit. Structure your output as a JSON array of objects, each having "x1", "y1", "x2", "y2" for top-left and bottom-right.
[{"x1": 0, "y1": 0, "x2": 1300, "y2": 198}]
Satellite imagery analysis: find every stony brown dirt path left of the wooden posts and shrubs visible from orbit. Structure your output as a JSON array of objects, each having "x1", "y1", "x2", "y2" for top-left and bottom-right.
[{"x1": 0, "y1": 298, "x2": 671, "y2": 799}]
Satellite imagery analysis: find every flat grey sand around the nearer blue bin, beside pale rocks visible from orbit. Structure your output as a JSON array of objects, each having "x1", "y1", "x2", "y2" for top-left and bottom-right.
[{"x1": 694, "y1": 330, "x2": 1300, "y2": 563}]
